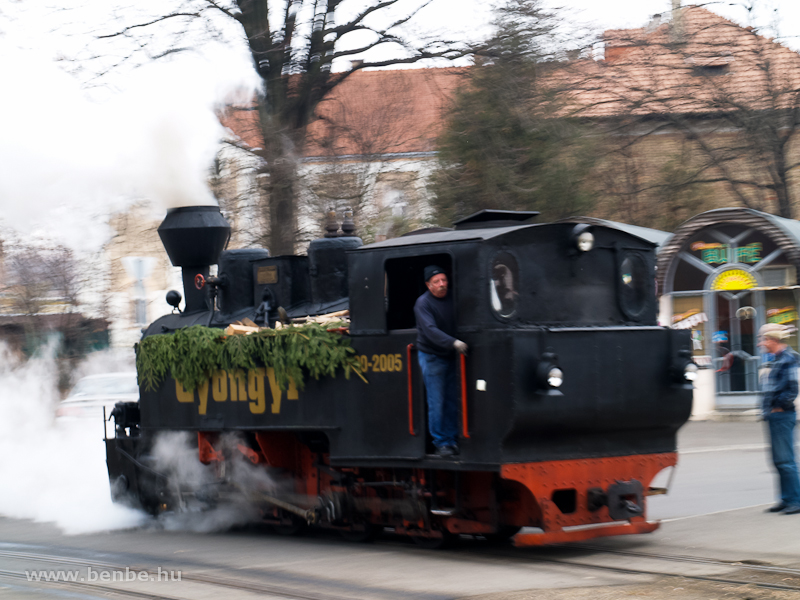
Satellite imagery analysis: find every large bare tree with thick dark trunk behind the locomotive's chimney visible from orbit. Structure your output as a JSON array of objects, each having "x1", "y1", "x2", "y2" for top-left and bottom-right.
[{"x1": 93, "y1": 0, "x2": 468, "y2": 254}]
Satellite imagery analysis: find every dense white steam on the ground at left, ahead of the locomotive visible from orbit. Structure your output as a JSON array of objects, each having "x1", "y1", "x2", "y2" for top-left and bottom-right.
[{"x1": 0, "y1": 344, "x2": 147, "y2": 534}]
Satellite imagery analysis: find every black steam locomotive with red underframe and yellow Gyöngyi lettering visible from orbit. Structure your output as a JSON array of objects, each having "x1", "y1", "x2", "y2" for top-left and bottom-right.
[{"x1": 106, "y1": 207, "x2": 696, "y2": 546}]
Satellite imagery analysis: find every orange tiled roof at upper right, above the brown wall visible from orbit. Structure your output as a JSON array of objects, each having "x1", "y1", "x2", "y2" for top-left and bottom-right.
[{"x1": 559, "y1": 6, "x2": 800, "y2": 117}]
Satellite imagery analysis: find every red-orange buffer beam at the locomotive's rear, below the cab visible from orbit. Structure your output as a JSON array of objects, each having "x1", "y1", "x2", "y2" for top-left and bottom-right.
[{"x1": 500, "y1": 452, "x2": 678, "y2": 546}]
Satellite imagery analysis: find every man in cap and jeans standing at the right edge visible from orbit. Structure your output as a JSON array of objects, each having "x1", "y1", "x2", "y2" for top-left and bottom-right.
[{"x1": 758, "y1": 323, "x2": 800, "y2": 515}]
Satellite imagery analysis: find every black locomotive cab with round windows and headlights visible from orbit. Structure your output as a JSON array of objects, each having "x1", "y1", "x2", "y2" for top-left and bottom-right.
[{"x1": 346, "y1": 211, "x2": 691, "y2": 466}]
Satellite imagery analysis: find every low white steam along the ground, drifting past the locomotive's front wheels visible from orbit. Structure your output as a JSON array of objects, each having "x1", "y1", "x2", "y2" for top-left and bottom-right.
[{"x1": 0, "y1": 343, "x2": 282, "y2": 534}]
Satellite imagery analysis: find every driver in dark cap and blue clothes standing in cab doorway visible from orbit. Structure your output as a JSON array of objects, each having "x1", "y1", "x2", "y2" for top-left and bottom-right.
[{"x1": 414, "y1": 265, "x2": 467, "y2": 458}]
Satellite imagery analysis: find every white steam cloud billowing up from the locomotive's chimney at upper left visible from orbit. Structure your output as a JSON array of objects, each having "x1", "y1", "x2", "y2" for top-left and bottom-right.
[{"x1": 0, "y1": 11, "x2": 258, "y2": 249}]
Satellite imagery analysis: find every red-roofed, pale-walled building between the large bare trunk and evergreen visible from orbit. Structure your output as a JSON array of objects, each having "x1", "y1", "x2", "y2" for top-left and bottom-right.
[{"x1": 222, "y1": 68, "x2": 464, "y2": 239}]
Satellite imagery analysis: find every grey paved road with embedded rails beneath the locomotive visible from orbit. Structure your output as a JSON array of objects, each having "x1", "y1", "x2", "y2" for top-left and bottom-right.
[{"x1": 0, "y1": 422, "x2": 800, "y2": 600}]
